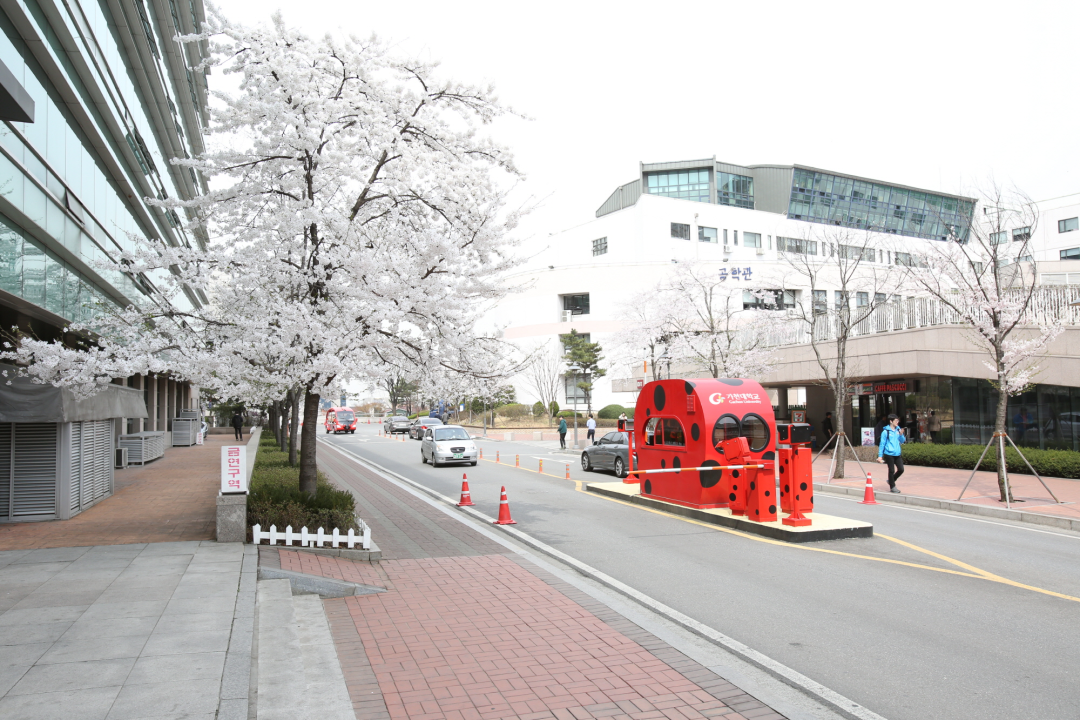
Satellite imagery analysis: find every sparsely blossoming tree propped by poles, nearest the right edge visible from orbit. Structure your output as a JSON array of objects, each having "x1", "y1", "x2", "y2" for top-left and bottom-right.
[{"x1": 914, "y1": 186, "x2": 1063, "y2": 502}]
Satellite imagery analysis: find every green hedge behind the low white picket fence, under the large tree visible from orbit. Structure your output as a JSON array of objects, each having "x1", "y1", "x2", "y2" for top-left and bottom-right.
[{"x1": 247, "y1": 432, "x2": 360, "y2": 532}]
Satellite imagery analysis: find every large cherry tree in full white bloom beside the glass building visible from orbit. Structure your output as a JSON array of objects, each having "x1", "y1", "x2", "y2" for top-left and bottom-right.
[{"x1": 1, "y1": 9, "x2": 518, "y2": 492}]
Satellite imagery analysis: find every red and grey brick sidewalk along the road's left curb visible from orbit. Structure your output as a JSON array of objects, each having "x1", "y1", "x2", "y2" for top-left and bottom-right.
[{"x1": 278, "y1": 444, "x2": 782, "y2": 720}]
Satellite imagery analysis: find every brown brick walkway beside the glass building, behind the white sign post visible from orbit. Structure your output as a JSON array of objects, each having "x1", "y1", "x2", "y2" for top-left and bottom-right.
[{"x1": 0, "y1": 435, "x2": 245, "y2": 551}]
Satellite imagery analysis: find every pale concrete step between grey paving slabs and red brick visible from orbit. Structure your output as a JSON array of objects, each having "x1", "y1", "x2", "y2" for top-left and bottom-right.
[{"x1": 256, "y1": 579, "x2": 355, "y2": 720}]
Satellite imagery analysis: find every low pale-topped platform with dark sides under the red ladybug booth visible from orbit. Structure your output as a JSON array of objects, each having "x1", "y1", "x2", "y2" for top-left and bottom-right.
[{"x1": 585, "y1": 483, "x2": 874, "y2": 543}]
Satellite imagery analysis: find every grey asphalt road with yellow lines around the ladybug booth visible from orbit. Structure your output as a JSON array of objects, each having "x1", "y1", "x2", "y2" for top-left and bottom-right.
[{"x1": 320, "y1": 425, "x2": 1080, "y2": 720}]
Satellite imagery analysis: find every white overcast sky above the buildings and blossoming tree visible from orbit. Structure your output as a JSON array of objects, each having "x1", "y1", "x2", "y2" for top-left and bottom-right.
[{"x1": 211, "y1": 0, "x2": 1080, "y2": 245}]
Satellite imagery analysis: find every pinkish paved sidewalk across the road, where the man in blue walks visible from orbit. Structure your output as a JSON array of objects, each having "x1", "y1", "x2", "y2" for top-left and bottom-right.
[{"x1": 813, "y1": 457, "x2": 1080, "y2": 519}]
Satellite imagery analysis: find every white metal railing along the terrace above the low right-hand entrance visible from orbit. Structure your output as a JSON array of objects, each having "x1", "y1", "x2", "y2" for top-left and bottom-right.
[{"x1": 765, "y1": 287, "x2": 1080, "y2": 348}]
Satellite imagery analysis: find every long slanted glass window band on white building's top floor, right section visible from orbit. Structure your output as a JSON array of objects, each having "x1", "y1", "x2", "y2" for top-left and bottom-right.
[{"x1": 787, "y1": 167, "x2": 974, "y2": 243}]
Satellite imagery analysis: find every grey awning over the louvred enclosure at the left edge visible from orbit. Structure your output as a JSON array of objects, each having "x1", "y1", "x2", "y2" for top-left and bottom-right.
[{"x1": 0, "y1": 365, "x2": 149, "y2": 422}]
